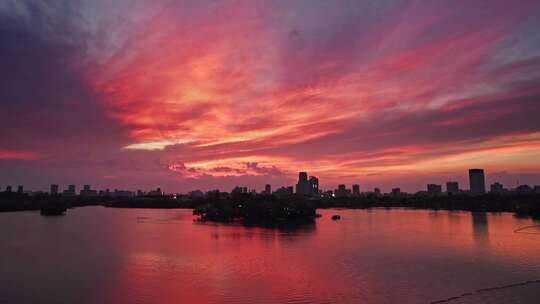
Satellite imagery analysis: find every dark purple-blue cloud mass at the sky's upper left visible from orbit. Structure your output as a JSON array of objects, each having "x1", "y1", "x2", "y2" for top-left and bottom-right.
[{"x1": 0, "y1": 1, "x2": 127, "y2": 154}]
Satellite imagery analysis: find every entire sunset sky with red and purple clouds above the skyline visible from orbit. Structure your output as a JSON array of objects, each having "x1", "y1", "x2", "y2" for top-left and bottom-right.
[{"x1": 0, "y1": 0, "x2": 540, "y2": 192}]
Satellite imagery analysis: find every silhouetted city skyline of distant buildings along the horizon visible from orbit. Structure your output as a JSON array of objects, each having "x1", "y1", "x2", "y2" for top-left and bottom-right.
[{"x1": 4, "y1": 168, "x2": 540, "y2": 199}]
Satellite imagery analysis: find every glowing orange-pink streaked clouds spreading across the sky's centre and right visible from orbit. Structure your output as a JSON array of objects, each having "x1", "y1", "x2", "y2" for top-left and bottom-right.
[{"x1": 80, "y1": 2, "x2": 540, "y2": 190}]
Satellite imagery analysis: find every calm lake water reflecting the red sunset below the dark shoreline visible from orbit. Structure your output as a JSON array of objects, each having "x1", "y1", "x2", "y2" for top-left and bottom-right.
[{"x1": 0, "y1": 207, "x2": 540, "y2": 303}]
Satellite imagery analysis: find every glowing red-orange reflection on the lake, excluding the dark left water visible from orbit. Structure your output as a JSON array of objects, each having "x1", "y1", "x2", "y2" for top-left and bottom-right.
[{"x1": 99, "y1": 210, "x2": 540, "y2": 303}]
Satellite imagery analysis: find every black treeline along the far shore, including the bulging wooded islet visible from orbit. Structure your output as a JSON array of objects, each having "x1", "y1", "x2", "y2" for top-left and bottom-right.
[{"x1": 0, "y1": 192, "x2": 540, "y2": 221}]
